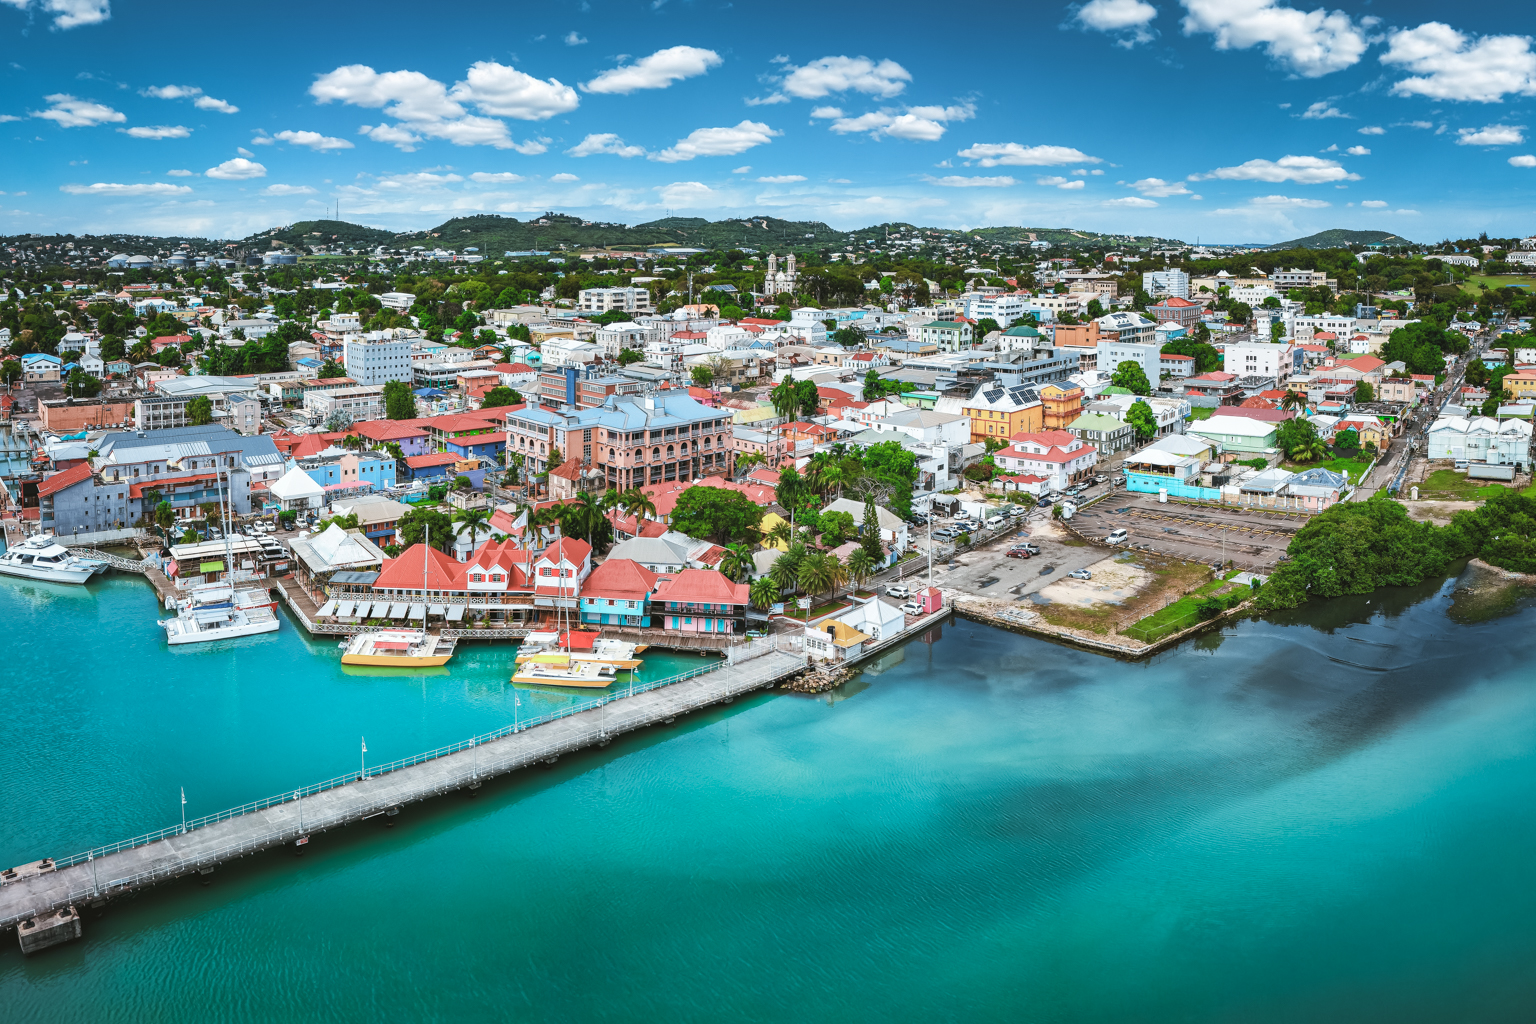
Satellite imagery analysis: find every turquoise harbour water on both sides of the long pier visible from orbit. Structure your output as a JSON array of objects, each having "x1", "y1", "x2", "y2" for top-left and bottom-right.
[{"x1": 0, "y1": 580, "x2": 1536, "y2": 1022}]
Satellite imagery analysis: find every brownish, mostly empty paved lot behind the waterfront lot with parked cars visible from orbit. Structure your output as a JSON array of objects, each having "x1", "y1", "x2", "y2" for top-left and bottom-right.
[{"x1": 1072, "y1": 491, "x2": 1309, "y2": 570}]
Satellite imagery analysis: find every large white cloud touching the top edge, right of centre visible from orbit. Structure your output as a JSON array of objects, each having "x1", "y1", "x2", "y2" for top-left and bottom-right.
[{"x1": 1181, "y1": 0, "x2": 1375, "y2": 78}]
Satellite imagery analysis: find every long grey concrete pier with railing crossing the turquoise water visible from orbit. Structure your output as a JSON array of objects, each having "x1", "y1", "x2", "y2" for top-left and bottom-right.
[{"x1": 0, "y1": 636, "x2": 805, "y2": 952}]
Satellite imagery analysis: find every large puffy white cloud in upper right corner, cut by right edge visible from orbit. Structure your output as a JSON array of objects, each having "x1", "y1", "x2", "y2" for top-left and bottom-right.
[{"x1": 1381, "y1": 21, "x2": 1536, "y2": 103}]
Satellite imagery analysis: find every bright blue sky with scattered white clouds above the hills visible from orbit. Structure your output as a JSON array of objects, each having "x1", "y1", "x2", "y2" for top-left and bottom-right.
[{"x1": 0, "y1": 0, "x2": 1536, "y2": 241}]
